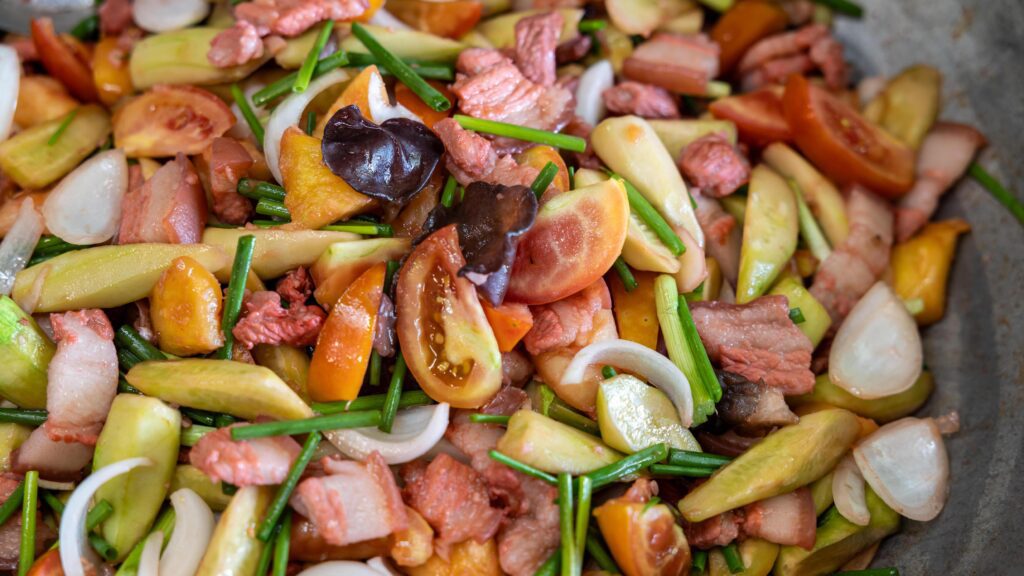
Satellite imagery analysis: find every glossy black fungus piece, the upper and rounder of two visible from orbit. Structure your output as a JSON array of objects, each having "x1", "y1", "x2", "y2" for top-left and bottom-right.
[{"x1": 321, "y1": 105, "x2": 444, "y2": 205}]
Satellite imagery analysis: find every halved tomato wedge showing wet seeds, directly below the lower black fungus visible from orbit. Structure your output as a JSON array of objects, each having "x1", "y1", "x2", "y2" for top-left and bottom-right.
[{"x1": 395, "y1": 224, "x2": 502, "y2": 408}]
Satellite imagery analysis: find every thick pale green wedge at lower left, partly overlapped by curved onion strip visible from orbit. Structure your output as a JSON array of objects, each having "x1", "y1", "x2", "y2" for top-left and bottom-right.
[{"x1": 92, "y1": 394, "x2": 181, "y2": 562}]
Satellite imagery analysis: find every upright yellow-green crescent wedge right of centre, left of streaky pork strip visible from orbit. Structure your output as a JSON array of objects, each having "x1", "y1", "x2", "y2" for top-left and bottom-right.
[{"x1": 736, "y1": 164, "x2": 800, "y2": 304}]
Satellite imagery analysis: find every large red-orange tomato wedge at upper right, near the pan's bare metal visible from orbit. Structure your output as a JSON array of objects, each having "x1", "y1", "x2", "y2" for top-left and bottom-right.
[{"x1": 782, "y1": 76, "x2": 914, "y2": 198}]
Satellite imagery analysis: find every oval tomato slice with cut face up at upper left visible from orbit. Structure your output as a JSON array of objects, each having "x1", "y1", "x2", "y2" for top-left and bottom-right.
[{"x1": 114, "y1": 84, "x2": 236, "y2": 158}]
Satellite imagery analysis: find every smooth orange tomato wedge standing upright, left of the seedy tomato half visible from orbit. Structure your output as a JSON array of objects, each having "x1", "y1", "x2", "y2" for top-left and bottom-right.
[{"x1": 308, "y1": 262, "x2": 387, "y2": 402}]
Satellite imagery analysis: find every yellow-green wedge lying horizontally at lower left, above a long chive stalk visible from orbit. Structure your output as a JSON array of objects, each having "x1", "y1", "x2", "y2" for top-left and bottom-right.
[{"x1": 125, "y1": 359, "x2": 313, "y2": 420}]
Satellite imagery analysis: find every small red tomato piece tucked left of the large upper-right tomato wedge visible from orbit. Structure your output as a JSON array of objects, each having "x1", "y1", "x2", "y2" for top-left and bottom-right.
[{"x1": 711, "y1": 86, "x2": 793, "y2": 148}]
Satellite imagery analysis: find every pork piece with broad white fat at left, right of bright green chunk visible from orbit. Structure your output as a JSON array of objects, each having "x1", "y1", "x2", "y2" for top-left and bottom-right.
[{"x1": 46, "y1": 310, "x2": 118, "y2": 446}]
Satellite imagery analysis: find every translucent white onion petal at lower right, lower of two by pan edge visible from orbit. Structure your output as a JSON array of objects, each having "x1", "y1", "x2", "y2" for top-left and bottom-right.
[{"x1": 853, "y1": 417, "x2": 949, "y2": 522}]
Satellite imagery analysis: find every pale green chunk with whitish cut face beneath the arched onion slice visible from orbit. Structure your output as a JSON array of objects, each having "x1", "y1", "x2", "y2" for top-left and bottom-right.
[{"x1": 597, "y1": 374, "x2": 700, "y2": 454}]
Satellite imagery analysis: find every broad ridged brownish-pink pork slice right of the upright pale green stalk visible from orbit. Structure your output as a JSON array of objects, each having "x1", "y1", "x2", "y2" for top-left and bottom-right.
[{"x1": 690, "y1": 296, "x2": 814, "y2": 396}]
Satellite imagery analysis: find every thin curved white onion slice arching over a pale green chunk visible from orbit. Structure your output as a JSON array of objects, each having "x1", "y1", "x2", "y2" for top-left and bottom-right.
[{"x1": 562, "y1": 339, "x2": 693, "y2": 428}]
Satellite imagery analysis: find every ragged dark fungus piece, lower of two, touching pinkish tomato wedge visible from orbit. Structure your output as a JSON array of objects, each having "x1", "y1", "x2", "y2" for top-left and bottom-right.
[{"x1": 423, "y1": 182, "x2": 537, "y2": 305}]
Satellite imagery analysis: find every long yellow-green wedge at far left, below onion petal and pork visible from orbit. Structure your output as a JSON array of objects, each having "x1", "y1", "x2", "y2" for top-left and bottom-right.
[{"x1": 11, "y1": 244, "x2": 227, "y2": 313}]
